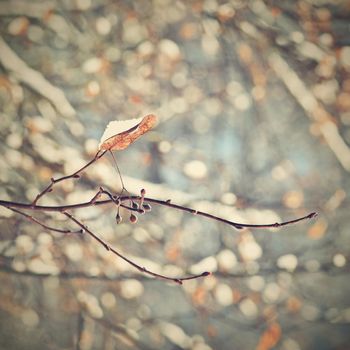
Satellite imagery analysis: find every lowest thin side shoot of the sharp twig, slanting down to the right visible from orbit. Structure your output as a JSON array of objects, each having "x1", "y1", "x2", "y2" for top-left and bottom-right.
[{"x1": 63, "y1": 211, "x2": 210, "y2": 284}]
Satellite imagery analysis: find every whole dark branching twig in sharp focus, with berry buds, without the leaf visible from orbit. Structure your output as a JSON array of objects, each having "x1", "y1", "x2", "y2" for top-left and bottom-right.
[{"x1": 0, "y1": 151, "x2": 317, "y2": 284}]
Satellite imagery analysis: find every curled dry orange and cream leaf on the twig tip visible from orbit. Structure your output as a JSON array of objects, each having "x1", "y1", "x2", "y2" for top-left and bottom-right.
[{"x1": 99, "y1": 114, "x2": 157, "y2": 151}]
